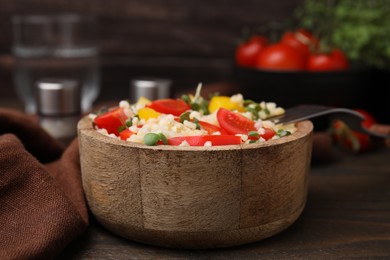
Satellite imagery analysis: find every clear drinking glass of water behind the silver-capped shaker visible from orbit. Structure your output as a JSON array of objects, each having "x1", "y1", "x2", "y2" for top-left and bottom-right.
[{"x1": 12, "y1": 13, "x2": 100, "y2": 113}]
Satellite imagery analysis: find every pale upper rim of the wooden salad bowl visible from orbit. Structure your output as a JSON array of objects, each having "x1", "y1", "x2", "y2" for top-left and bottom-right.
[{"x1": 77, "y1": 116, "x2": 314, "y2": 152}]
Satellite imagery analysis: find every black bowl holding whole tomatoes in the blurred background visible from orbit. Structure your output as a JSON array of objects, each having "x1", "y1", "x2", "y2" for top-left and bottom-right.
[{"x1": 234, "y1": 65, "x2": 390, "y2": 125}]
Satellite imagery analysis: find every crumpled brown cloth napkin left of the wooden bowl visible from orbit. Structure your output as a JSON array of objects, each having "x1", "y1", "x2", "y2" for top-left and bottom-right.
[{"x1": 0, "y1": 108, "x2": 88, "y2": 260}]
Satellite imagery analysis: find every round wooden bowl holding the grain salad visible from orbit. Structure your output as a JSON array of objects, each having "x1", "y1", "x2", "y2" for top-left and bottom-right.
[{"x1": 78, "y1": 117, "x2": 313, "y2": 249}]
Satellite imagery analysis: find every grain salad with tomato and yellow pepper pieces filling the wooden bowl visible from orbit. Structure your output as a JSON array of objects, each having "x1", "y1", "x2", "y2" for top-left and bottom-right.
[{"x1": 89, "y1": 84, "x2": 296, "y2": 146}]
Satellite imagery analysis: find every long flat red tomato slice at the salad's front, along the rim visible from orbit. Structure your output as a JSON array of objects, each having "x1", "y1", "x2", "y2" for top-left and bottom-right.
[{"x1": 168, "y1": 135, "x2": 241, "y2": 146}]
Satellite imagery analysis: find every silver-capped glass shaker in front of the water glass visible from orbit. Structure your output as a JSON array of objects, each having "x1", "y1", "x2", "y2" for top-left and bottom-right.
[{"x1": 36, "y1": 78, "x2": 81, "y2": 145}]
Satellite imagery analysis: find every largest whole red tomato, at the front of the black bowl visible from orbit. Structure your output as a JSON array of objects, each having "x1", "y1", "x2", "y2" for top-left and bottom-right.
[{"x1": 256, "y1": 43, "x2": 307, "y2": 71}]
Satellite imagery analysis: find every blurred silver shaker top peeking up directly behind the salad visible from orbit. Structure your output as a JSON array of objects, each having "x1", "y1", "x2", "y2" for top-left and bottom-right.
[{"x1": 130, "y1": 77, "x2": 172, "y2": 103}]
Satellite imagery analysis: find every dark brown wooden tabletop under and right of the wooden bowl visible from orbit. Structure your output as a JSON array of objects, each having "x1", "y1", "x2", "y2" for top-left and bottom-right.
[{"x1": 59, "y1": 149, "x2": 390, "y2": 259}]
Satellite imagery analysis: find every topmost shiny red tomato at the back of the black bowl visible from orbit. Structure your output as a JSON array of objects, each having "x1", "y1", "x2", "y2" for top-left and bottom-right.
[{"x1": 280, "y1": 28, "x2": 319, "y2": 57}]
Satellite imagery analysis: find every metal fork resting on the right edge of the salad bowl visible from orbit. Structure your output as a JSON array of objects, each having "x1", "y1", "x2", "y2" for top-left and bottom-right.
[{"x1": 269, "y1": 105, "x2": 390, "y2": 138}]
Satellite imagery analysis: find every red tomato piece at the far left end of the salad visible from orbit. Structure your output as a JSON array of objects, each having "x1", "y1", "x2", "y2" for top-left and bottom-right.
[{"x1": 93, "y1": 107, "x2": 127, "y2": 136}]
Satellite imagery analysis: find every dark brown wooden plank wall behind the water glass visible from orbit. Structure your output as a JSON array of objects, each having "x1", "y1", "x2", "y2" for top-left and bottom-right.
[{"x1": 0, "y1": 0, "x2": 302, "y2": 104}]
